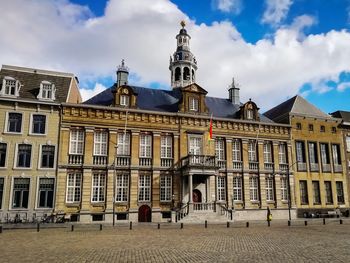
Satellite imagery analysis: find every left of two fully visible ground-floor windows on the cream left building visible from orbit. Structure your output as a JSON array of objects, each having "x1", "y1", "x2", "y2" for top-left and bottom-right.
[{"x1": 12, "y1": 178, "x2": 30, "y2": 208}]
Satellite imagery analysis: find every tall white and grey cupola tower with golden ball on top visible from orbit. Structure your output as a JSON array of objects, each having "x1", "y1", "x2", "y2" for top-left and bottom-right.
[{"x1": 169, "y1": 21, "x2": 197, "y2": 88}]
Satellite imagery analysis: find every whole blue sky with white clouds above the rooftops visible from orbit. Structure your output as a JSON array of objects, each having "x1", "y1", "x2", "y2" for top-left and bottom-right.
[{"x1": 0, "y1": 0, "x2": 350, "y2": 113}]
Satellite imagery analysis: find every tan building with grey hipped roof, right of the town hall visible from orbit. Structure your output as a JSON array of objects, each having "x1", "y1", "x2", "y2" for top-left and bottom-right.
[{"x1": 265, "y1": 96, "x2": 349, "y2": 216}]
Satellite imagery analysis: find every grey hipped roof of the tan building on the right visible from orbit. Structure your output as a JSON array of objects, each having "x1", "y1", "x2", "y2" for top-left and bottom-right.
[{"x1": 264, "y1": 95, "x2": 331, "y2": 123}]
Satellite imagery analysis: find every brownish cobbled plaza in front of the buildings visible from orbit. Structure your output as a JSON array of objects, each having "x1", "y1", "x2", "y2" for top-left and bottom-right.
[{"x1": 0, "y1": 221, "x2": 350, "y2": 262}]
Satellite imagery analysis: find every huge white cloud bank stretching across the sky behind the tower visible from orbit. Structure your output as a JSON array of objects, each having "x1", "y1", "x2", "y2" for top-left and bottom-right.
[{"x1": 0, "y1": 0, "x2": 350, "y2": 111}]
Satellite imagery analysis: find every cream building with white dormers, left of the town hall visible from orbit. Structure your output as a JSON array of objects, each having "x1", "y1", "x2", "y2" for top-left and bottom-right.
[{"x1": 0, "y1": 65, "x2": 81, "y2": 222}]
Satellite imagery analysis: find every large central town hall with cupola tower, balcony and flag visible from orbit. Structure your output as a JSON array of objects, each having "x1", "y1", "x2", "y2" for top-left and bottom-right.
[{"x1": 56, "y1": 24, "x2": 295, "y2": 222}]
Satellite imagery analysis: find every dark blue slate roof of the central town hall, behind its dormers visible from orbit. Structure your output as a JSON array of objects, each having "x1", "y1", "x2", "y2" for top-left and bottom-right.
[{"x1": 84, "y1": 86, "x2": 272, "y2": 122}]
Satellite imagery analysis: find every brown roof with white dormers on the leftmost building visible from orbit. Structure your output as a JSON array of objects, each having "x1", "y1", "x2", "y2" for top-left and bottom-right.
[{"x1": 0, "y1": 65, "x2": 74, "y2": 103}]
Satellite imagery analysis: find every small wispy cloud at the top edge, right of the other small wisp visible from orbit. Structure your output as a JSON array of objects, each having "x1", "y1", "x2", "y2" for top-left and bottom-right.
[{"x1": 261, "y1": 0, "x2": 293, "y2": 26}]
